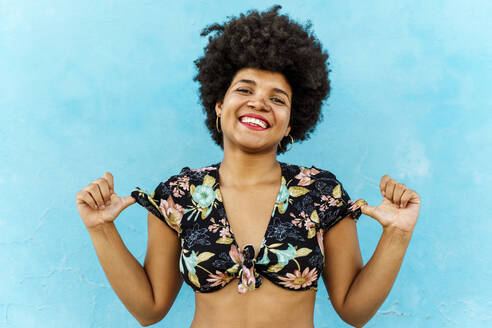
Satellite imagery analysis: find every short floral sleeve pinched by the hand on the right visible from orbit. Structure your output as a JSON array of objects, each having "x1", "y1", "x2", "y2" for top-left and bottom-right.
[{"x1": 313, "y1": 166, "x2": 363, "y2": 231}]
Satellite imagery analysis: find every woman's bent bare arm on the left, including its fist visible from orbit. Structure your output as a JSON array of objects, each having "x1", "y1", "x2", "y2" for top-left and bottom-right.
[{"x1": 75, "y1": 172, "x2": 182, "y2": 326}]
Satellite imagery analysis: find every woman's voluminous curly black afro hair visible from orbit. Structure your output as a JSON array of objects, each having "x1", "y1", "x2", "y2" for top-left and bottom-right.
[{"x1": 193, "y1": 5, "x2": 330, "y2": 154}]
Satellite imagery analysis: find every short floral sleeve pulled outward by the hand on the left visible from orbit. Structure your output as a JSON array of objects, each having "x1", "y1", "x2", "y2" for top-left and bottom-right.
[{"x1": 131, "y1": 176, "x2": 183, "y2": 234}]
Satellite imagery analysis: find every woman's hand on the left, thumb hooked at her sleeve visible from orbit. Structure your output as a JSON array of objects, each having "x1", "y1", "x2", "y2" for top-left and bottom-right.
[{"x1": 75, "y1": 172, "x2": 136, "y2": 230}]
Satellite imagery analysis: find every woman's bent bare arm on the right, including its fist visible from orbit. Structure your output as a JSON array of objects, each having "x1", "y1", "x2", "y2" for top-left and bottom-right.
[{"x1": 323, "y1": 175, "x2": 420, "y2": 327}]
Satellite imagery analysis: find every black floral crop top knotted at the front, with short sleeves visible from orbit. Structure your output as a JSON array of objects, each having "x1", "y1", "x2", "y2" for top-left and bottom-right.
[{"x1": 131, "y1": 162, "x2": 365, "y2": 293}]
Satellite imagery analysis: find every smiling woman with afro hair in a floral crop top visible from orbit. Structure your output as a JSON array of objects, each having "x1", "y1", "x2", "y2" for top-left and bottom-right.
[{"x1": 77, "y1": 6, "x2": 420, "y2": 328}]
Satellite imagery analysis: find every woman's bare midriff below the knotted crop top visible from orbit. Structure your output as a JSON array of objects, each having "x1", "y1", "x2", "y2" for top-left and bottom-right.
[{"x1": 191, "y1": 278, "x2": 316, "y2": 328}]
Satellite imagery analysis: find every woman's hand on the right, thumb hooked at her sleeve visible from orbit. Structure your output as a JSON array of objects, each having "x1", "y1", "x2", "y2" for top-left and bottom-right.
[{"x1": 361, "y1": 174, "x2": 420, "y2": 233}]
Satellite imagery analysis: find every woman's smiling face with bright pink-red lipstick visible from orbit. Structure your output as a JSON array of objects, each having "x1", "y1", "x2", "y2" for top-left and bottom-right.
[{"x1": 215, "y1": 68, "x2": 292, "y2": 153}]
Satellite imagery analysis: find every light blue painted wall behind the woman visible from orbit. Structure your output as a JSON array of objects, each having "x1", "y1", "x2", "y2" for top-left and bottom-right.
[{"x1": 0, "y1": 0, "x2": 492, "y2": 328}]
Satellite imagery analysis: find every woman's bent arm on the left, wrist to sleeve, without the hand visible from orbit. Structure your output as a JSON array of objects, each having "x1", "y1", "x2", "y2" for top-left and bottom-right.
[{"x1": 88, "y1": 213, "x2": 182, "y2": 326}]
